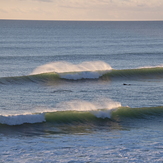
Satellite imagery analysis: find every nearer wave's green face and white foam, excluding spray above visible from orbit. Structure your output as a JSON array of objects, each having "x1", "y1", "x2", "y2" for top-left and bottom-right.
[{"x1": 0, "y1": 106, "x2": 163, "y2": 126}]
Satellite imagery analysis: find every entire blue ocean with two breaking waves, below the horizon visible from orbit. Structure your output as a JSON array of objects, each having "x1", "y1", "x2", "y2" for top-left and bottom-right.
[{"x1": 0, "y1": 20, "x2": 163, "y2": 163}]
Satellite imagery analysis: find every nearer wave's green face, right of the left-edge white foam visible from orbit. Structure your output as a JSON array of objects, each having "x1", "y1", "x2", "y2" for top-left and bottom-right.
[{"x1": 45, "y1": 106, "x2": 163, "y2": 124}]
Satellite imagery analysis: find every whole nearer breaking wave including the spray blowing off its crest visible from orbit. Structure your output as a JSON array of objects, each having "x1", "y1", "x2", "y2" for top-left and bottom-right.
[{"x1": 0, "y1": 100, "x2": 163, "y2": 126}]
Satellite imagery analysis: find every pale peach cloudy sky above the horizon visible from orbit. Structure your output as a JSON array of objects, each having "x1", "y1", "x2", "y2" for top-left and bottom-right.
[{"x1": 0, "y1": 0, "x2": 163, "y2": 21}]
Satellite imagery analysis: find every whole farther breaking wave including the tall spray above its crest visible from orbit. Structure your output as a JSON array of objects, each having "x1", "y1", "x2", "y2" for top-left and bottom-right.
[{"x1": 0, "y1": 61, "x2": 163, "y2": 84}]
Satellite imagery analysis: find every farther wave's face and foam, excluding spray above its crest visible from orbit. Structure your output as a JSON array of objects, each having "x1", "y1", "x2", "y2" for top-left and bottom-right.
[{"x1": 0, "y1": 67, "x2": 163, "y2": 84}]
